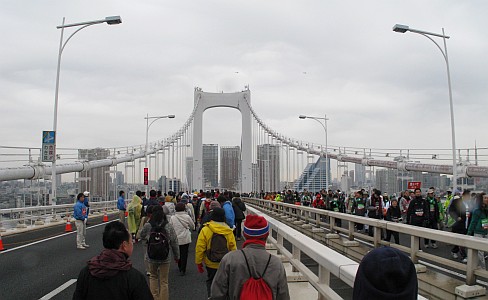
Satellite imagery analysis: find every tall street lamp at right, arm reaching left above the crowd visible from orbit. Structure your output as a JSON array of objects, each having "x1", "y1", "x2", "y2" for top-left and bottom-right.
[{"x1": 393, "y1": 24, "x2": 457, "y2": 192}]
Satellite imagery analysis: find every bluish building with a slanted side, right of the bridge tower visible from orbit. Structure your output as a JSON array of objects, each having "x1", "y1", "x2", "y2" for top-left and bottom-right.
[{"x1": 293, "y1": 157, "x2": 334, "y2": 193}]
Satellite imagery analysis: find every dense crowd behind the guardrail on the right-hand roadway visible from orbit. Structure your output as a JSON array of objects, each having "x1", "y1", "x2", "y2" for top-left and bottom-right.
[{"x1": 250, "y1": 187, "x2": 488, "y2": 269}]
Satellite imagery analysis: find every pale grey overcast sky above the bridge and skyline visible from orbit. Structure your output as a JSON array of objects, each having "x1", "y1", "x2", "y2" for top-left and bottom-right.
[{"x1": 0, "y1": 0, "x2": 488, "y2": 164}]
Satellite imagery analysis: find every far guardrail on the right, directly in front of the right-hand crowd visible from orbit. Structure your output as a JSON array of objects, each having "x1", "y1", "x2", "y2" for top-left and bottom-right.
[{"x1": 243, "y1": 198, "x2": 488, "y2": 285}]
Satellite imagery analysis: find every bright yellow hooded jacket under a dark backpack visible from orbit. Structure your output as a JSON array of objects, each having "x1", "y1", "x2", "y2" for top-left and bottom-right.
[{"x1": 195, "y1": 221, "x2": 237, "y2": 269}]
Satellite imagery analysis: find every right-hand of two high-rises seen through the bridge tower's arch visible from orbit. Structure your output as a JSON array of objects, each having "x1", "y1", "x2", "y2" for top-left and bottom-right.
[{"x1": 220, "y1": 146, "x2": 241, "y2": 191}]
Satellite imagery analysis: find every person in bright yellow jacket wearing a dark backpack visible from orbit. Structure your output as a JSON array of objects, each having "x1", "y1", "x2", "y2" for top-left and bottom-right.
[{"x1": 195, "y1": 207, "x2": 237, "y2": 299}]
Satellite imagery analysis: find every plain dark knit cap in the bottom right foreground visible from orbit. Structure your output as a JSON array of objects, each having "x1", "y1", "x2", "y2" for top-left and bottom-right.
[{"x1": 353, "y1": 247, "x2": 418, "y2": 300}]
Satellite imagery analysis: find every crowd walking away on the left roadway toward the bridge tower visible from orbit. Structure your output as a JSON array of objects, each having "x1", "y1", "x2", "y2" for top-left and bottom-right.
[{"x1": 73, "y1": 190, "x2": 290, "y2": 300}]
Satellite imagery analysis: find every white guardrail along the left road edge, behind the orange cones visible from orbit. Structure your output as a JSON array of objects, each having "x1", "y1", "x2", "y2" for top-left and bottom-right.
[{"x1": 0, "y1": 200, "x2": 117, "y2": 232}]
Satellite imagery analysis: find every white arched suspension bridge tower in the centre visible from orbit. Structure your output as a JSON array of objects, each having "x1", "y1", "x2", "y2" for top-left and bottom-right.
[{"x1": 192, "y1": 88, "x2": 252, "y2": 193}]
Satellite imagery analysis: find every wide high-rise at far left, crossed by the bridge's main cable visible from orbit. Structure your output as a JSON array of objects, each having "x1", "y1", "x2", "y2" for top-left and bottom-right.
[{"x1": 78, "y1": 148, "x2": 112, "y2": 200}]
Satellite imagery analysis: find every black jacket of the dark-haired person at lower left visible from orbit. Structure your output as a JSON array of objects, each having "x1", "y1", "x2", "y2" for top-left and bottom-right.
[{"x1": 73, "y1": 249, "x2": 153, "y2": 300}]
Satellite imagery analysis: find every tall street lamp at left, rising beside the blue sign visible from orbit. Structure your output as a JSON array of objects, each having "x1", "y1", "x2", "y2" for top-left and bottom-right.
[{"x1": 51, "y1": 16, "x2": 122, "y2": 205}]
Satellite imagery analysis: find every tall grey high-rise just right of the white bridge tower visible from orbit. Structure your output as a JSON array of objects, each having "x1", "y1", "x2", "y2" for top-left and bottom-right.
[{"x1": 257, "y1": 144, "x2": 280, "y2": 192}]
